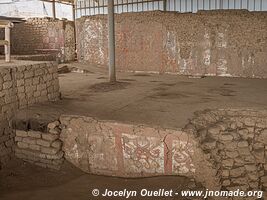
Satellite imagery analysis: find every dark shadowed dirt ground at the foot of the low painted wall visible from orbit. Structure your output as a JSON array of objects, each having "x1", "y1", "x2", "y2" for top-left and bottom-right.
[{"x1": 0, "y1": 160, "x2": 201, "y2": 200}]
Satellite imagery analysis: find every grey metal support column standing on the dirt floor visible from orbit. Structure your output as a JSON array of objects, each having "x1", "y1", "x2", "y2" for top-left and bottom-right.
[{"x1": 108, "y1": 0, "x2": 116, "y2": 82}]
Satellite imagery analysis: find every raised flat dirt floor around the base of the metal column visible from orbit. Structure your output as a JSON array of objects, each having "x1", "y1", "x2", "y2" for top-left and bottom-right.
[{"x1": 19, "y1": 63, "x2": 267, "y2": 129}]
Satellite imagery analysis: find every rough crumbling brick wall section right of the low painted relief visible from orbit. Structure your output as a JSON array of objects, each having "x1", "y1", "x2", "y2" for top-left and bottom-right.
[{"x1": 184, "y1": 109, "x2": 267, "y2": 198}]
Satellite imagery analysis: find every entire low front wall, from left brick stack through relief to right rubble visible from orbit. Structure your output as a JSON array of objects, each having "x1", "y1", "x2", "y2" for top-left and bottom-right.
[{"x1": 11, "y1": 109, "x2": 267, "y2": 195}]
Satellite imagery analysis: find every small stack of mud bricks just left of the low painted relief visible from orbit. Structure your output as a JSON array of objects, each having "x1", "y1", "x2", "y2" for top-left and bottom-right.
[{"x1": 15, "y1": 121, "x2": 64, "y2": 170}]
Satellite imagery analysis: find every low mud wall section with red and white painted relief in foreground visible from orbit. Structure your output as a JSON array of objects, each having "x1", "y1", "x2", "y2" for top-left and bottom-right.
[{"x1": 59, "y1": 115, "x2": 216, "y2": 188}]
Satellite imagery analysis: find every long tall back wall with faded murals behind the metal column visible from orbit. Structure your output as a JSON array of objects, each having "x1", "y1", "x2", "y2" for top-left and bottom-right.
[{"x1": 76, "y1": 10, "x2": 267, "y2": 78}]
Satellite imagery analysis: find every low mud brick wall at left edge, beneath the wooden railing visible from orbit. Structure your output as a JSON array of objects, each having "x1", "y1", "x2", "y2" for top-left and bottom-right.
[{"x1": 0, "y1": 61, "x2": 59, "y2": 167}]
